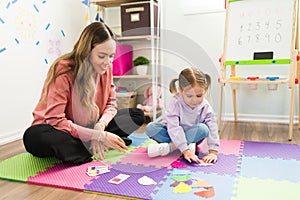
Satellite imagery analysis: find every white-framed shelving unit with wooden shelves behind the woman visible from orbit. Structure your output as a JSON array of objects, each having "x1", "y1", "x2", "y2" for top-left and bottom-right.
[{"x1": 90, "y1": 0, "x2": 162, "y2": 121}]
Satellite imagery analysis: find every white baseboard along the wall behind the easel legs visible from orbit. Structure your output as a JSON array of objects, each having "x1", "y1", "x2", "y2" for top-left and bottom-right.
[{"x1": 222, "y1": 113, "x2": 298, "y2": 124}]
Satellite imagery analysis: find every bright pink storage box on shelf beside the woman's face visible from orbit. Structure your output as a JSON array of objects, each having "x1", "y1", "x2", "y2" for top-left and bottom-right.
[{"x1": 112, "y1": 44, "x2": 132, "y2": 76}]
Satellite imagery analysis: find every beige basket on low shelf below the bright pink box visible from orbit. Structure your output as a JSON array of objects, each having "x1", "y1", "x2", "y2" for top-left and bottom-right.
[{"x1": 117, "y1": 92, "x2": 137, "y2": 109}]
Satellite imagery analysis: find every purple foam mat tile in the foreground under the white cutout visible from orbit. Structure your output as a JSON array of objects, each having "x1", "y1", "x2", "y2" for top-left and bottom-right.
[{"x1": 84, "y1": 168, "x2": 168, "y2": 199}]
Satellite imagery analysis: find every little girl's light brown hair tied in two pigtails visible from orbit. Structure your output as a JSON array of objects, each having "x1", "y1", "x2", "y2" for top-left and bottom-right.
[{"x1": 169, "y1": 67, "x2": 211, "y2": 94}]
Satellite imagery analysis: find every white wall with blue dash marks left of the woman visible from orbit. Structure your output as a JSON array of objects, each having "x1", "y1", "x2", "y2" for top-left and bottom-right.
[{"x1": 0, "y1": 0, "x2": 88, "y2": 145}]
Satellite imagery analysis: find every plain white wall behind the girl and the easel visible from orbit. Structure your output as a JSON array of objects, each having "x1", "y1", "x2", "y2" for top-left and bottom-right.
[{"x1": 162, "y1": 0, "x2": 298, "y2": 122}]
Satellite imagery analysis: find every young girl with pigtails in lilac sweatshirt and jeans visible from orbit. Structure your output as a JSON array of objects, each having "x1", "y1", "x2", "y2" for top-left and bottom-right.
[{"x1": 146, "y1": 68, "x2": 220, "y2": 163}]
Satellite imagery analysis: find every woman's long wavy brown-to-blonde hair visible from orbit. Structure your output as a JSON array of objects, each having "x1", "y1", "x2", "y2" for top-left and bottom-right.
[{"x1": 43, "y1": 22, "x2": 115, "y2": 119}]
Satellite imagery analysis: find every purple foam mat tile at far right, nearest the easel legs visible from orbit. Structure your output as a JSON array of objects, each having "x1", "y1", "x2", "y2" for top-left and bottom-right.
[{"x1": 243, "y1": 141, "x2": 300, "y2": 160}]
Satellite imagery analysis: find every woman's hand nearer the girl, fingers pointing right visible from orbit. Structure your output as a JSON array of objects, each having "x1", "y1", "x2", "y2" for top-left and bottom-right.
[{"x1": 102, "y1": 132, "x2": 128, "y2": 152}]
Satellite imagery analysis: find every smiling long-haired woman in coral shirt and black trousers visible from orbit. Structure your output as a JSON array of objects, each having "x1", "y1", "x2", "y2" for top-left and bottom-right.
[{"x1": 23, "y1": 22, "x2": 144, "y2": 164}]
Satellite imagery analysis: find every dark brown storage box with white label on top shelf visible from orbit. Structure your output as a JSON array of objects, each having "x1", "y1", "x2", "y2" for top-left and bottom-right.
[{"x1": 121, "y1": 1, "x2": 158, "y2": 36}]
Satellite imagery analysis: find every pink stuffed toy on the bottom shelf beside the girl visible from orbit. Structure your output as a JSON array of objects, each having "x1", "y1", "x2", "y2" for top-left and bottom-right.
[{"x1": 136, "y1": 85, "x2": 163, "y2": 112}]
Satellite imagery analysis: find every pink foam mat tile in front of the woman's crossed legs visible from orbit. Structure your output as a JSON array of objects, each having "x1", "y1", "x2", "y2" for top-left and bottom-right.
[{"x1": 27, "y1": 161, "x2": 104, "y2": 191}]
